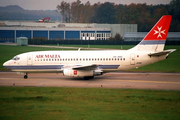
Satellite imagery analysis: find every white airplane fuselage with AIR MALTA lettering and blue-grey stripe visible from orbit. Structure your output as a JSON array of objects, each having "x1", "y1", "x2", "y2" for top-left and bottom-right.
[{"x1": 4, "y1": 50, "x2": 167, "y2": 73}]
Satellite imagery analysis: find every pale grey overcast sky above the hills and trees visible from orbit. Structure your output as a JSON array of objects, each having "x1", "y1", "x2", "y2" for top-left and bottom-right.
[{"x1": 0, "y1": 0, "x2": 171, "y2": 10}]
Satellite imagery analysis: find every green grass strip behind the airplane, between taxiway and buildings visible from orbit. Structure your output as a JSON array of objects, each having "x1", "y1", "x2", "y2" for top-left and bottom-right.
[{"x1": 0, "y1": 45, "x2": 180, "y2": 72}]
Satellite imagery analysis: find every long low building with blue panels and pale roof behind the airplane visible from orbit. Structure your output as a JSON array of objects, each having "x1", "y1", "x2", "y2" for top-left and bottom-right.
[{"x1": 0, "y1": 21, "x2": 137, "y2": 42}]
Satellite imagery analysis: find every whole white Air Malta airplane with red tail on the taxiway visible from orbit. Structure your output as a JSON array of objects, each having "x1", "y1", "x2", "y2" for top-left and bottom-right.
[{"x1": 3, "y1": 15, "x2": 176, "y2": 79}]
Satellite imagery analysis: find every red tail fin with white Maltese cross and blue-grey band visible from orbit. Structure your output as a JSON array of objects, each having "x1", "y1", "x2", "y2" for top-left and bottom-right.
[{"x1": 132, "y1": 15, "x2": 172, "y2": 52}]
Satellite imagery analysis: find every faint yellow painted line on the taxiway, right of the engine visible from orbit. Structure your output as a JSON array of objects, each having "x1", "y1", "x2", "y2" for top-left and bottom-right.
[{"x1": 105, "y1": 80, "x2": 180, "y2": 84}]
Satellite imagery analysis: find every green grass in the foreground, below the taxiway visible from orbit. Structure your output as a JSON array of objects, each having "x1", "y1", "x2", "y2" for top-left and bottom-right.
[{"x1": 0, "y1": 87, "x2": 180, "y2": 120}]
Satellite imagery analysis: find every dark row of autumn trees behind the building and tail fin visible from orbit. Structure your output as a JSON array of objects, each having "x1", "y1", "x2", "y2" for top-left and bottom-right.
[{"x1": 56, "y1": 0, "x2": 180, "y2": 32}]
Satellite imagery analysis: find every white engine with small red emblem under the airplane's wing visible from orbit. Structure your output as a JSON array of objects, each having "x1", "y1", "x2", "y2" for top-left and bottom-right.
[{"x1": 63, "y1": 69, "x2": 102, "y2": 77}]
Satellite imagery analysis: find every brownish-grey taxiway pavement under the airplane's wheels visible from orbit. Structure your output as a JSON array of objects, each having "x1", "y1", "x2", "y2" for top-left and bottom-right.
[{"x1": 0, "y1": 72, "x2": 180, "y2": 90}]
